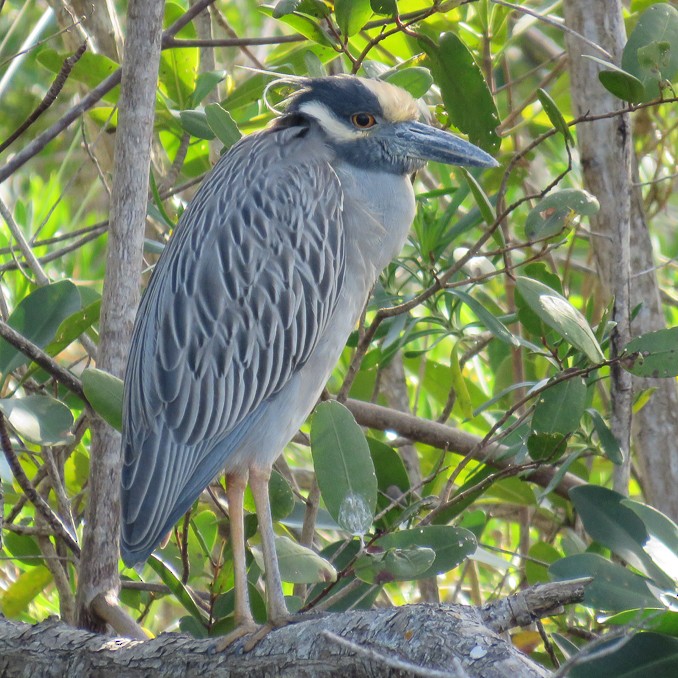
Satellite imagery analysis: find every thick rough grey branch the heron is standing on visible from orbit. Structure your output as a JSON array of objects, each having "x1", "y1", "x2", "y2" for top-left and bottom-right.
[{"x1": 0, "y1": 579, "x2": 590, "y2": 678}]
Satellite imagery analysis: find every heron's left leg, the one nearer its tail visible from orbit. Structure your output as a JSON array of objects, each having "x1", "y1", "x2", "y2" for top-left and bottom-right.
[{"x1": 226, "y1": 471, "x2": 256, "y2": 631}]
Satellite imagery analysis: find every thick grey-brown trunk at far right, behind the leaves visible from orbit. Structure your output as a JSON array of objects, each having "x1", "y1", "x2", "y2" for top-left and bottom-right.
[{"x1": 564, "y1": 0, "x2": 678, "y2": 519}]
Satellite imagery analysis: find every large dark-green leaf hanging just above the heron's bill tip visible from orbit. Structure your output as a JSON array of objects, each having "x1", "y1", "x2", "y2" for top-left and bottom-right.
[{"x1": 418, "y1": 33, "x2": 501, "y2": 153}]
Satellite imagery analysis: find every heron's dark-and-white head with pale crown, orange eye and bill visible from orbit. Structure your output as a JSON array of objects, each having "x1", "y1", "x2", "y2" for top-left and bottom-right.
[{"x1": 287, "y1": 76, "x2": 497, "y2": 174}]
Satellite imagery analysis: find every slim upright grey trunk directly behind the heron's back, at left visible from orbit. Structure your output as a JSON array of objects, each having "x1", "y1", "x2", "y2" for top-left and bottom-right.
[{"x1": 77, "y1": 0, "x2": 164, "y2": 631}]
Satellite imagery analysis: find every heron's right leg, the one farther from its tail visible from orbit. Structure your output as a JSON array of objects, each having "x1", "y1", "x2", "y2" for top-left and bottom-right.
[{"x1": 250, "y1": 466, "x2": 290, "y2": 626}]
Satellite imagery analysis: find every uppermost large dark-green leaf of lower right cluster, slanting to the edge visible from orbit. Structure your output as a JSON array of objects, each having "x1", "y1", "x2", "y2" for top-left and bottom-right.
[{"x1": 569, "y1": 485, "x2": 674, "y2": 587}]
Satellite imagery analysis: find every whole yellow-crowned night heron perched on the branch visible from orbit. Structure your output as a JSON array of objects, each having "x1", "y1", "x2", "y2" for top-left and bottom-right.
[{"x1": 122, "y1": 76, "x2": 496, "y2": 632}]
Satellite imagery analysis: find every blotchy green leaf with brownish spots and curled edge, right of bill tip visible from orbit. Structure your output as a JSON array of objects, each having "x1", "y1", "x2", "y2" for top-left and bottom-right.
[{"x1": 525, "y1": 188, "x2": 600, "y2": 240}]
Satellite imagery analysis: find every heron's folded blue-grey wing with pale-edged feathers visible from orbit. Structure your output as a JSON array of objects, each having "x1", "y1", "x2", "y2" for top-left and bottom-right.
[{"x1": 122, "y1": 122, "x2": 344, "y2": 563}]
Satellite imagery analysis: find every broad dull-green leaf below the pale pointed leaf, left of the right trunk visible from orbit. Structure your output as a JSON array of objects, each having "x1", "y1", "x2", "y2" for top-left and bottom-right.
[{"x1": 532, "y1": 377, "x2": 586, "y2": 435}]
